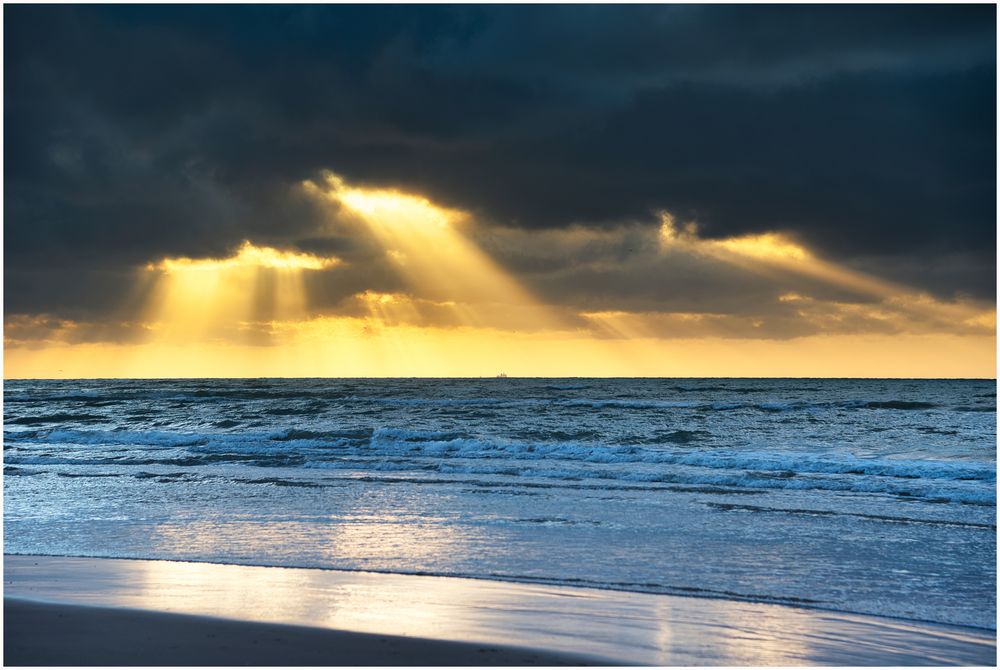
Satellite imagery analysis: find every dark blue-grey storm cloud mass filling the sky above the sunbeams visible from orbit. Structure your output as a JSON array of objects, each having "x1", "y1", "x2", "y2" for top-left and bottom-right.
[{"x1": 4, "y1": 5, "x2": 996, "y2": 320}]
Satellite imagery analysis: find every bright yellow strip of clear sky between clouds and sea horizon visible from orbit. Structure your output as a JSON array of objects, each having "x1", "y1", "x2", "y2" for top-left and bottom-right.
[{"x1": 4, "y1": 330, "x2": 996, "y2": 379}]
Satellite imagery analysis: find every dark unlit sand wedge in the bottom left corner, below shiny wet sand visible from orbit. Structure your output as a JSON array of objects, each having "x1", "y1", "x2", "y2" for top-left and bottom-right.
[{"x1": 3, "y1": 598, "x2": 594, "y2": 666}]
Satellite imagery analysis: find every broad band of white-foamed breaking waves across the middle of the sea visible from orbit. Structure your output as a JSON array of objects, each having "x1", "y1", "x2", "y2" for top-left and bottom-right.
[{"x1": 6, "y1": 427, "x2": 996, "y2": 504}]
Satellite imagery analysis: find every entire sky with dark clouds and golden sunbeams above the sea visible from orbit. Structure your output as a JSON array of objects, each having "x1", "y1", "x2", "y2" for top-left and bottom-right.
[{"x1": 3, "y1": 5, "x2": 997, "y2": 378}]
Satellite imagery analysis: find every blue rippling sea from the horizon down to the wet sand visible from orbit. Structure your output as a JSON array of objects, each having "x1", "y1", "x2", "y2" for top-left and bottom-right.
[{"x1": 4, "y1": 379, "x2": 996, "y2": 628}]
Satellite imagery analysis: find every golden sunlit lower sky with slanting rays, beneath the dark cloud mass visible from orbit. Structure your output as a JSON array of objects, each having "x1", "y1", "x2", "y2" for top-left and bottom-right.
[{"x1": 4, "y1": 181, "x2": 996, "y2": 378}]
